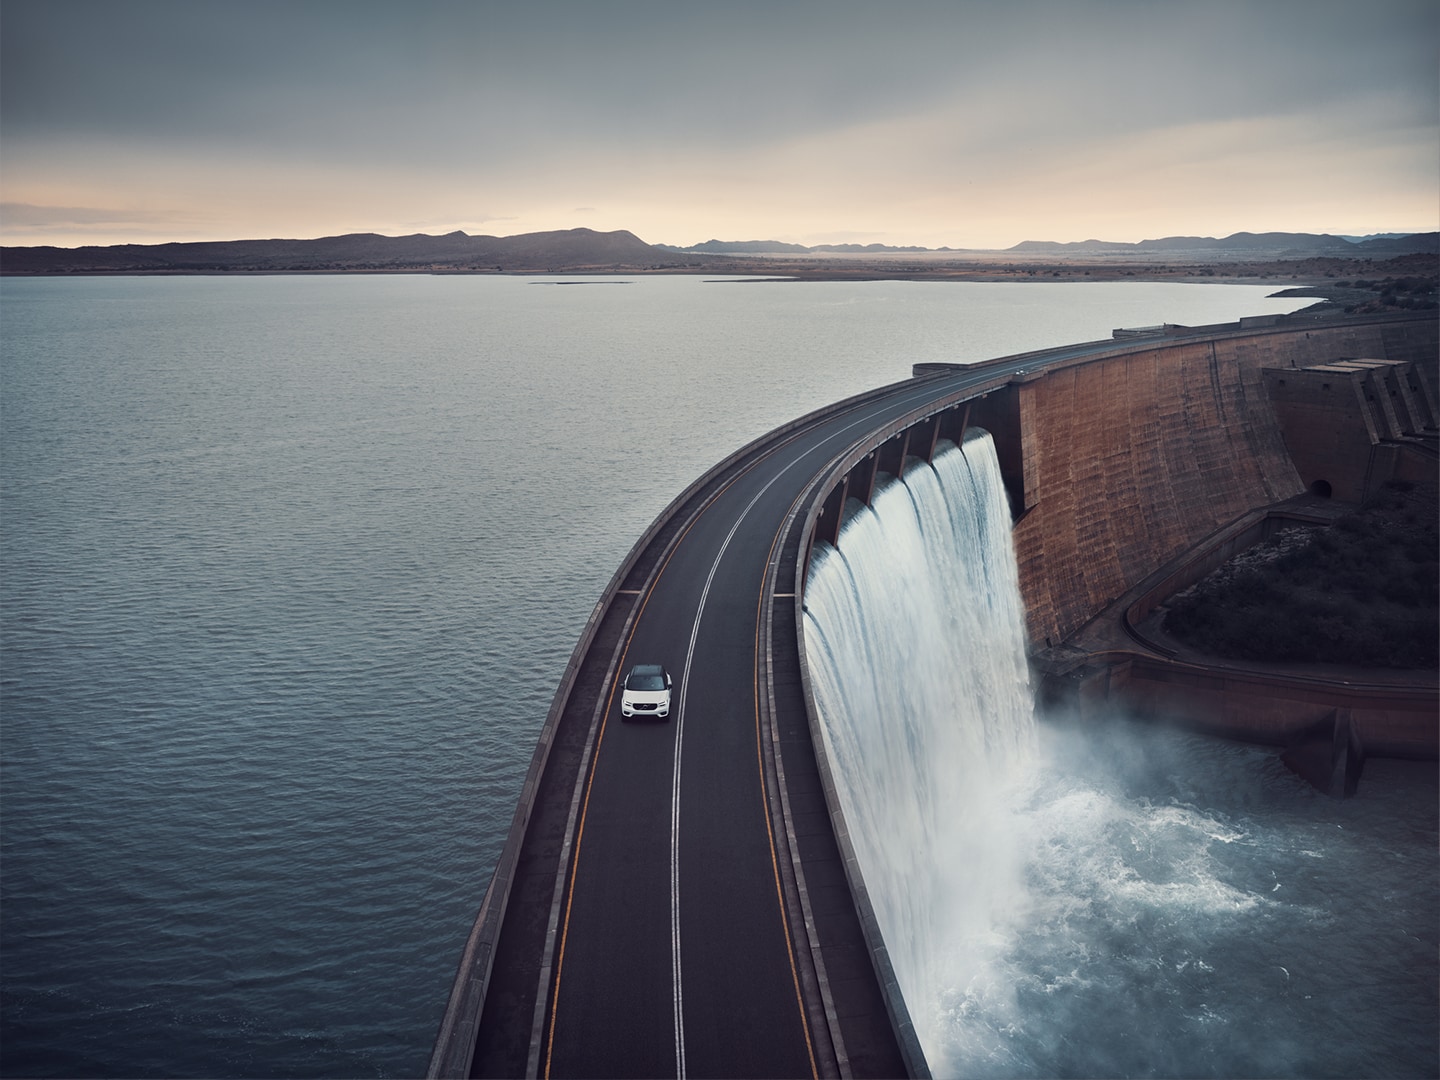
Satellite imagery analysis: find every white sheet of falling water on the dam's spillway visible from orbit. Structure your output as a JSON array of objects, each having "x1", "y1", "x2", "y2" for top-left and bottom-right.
[{"x1": 805, "y1": 429, "x2": 1038, "y2": 1066}]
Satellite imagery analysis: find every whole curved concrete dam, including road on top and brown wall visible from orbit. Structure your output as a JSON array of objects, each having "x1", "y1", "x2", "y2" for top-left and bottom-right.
[{"x1": 429, "y1": 308, "x2": 1440, "y2": 1076}]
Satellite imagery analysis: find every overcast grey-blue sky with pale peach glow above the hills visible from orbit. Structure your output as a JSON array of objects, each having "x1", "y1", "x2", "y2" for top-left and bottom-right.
[{"x1": 0, "y1": 0, "x2": 1440, "y2": 248}]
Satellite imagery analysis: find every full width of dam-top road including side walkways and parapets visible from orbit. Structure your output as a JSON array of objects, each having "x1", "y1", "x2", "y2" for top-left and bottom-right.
[{"x1": 431, "y1": 332, "x2": 1157, "y2": 1077}]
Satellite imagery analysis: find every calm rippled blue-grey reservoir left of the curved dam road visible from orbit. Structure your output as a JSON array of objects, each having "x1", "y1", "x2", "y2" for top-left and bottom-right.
[{"x1": 0, "y1": 276, "x2": 1393, "y2": 1076}]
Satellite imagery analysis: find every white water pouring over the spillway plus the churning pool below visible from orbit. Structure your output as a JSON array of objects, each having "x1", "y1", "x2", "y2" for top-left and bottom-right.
[{"x1": 805, "y1": 436, "x2": 1440, "y2": 1077}]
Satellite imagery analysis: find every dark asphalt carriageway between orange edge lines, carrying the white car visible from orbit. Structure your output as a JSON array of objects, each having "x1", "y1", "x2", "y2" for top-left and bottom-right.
[{"x1": 539, "y1": 364, "x2": 1020, "y2": 1077}]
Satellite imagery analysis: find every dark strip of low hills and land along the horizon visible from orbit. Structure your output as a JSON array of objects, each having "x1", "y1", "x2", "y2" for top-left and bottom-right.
[{"x1": 0, "y1": 229, "x2": 1440, "y2": 287}]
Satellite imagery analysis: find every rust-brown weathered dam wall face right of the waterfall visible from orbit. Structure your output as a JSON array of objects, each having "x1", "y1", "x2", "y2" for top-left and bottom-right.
[{"x1": 1013, "y1": 320, "x2": 1437, "y2": 645}]
